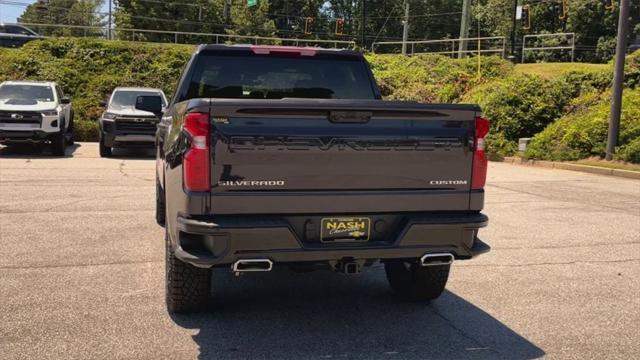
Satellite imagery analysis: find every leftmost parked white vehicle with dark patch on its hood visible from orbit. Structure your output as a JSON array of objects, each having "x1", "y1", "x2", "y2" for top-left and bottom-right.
[{"x1": 0, "y1": 81, "x2": 73, "y2": 156}]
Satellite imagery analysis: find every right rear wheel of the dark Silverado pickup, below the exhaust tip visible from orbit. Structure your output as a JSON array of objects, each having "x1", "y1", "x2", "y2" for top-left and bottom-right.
[{"x1": 384, "y1": 260, "x2": 451, "y2": 301}]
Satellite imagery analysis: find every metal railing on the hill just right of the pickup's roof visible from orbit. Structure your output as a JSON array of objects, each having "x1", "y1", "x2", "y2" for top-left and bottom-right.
[{"x1": 371, "y1": 36, "x2": 507, "y2": 57}]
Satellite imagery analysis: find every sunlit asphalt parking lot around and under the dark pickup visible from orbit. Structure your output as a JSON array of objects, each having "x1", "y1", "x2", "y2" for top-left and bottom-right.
[{"x1": 0, "y1": 143, "x2": 640, "y2": 359}]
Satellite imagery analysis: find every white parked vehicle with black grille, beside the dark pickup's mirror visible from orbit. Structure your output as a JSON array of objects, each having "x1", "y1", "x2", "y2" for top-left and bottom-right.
[{"x1": 99, "y1": 87, "x2": 167, "y2": 157}]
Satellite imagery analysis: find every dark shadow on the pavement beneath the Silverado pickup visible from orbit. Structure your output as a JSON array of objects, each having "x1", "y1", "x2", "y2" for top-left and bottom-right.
[{"x1": 172, "y1": 266, "x2": 544, "y2": 359}]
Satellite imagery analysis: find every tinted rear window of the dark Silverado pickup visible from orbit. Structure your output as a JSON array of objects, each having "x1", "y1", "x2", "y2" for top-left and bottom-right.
[{"x1": 182, "y1": 53, "x2": 375, "y2": 100}]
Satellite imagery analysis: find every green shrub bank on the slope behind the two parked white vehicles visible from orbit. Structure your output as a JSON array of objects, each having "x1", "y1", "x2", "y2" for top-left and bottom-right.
[{"x1": 0, "y1": 38, "x2": 193, "y2": 137}]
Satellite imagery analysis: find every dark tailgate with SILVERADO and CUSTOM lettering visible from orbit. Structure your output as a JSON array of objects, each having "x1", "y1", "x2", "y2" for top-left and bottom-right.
[{"x1": 211, "y1": 99, "x2": 477, "y2": 210}]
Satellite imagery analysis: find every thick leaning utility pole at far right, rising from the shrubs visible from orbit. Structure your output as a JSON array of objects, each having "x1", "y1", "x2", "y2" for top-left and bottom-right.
[{"x1": 605, "y1": 0, "x2": 629, "y2": 160}]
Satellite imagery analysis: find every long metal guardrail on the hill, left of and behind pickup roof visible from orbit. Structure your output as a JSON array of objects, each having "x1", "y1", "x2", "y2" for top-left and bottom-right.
[{"x1": 20, "y1": 23, "x2": 356, "y2": 49}]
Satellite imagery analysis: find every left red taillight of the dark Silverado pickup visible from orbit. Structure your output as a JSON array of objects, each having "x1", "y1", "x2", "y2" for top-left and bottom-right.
[{"x1": 182, "y1": 113, "x2": 211, "y2": 192}]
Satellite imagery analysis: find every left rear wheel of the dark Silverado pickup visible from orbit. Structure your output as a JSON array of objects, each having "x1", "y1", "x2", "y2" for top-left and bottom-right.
[{"x1": 165, "y1": 234, "x2": 211, "y2": 313}]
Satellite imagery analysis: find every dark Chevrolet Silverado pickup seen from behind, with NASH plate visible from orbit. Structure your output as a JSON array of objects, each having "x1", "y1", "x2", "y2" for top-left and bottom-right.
[{"x1": 136, "y1": 45, "x2": 489, "y2": 312}]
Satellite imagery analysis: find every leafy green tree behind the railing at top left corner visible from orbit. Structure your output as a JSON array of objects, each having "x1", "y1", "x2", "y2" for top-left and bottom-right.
[{"x1": 18, "y1": 0, "x2": 103, "y2": 36}]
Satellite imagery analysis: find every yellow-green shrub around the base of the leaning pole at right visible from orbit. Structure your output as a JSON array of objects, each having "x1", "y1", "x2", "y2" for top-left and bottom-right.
[{"x1": 526, "y1": 89, "x2": 640, "y2": 162}]
